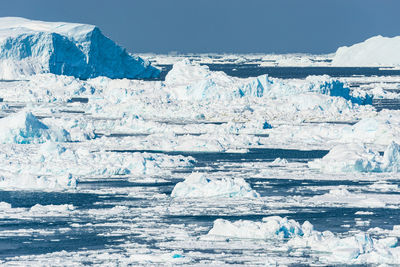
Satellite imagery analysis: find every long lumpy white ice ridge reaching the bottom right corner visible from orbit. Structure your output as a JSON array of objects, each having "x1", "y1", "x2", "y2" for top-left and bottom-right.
[{"x1": 202, "y1": 216, "x2": 400, "y2": 264}]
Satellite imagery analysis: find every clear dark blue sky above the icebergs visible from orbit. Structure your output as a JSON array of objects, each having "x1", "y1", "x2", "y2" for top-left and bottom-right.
[{"x1": 0, "y1": 0, "x2": 400, "y2": 53}]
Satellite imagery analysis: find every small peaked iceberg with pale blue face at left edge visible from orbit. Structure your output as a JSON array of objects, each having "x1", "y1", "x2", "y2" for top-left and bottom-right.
[{"x1": 0, "y1": 111, "x2": 71, "y2": 144}]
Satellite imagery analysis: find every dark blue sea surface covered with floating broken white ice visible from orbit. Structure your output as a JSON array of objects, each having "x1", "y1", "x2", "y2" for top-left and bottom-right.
[{"x1": 0, "y1": 63, "x2": 400, "y2": 266}]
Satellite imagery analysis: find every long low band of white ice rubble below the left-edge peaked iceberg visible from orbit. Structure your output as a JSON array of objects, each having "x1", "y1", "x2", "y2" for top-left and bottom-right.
[{"x1": 0, "y1": 141, "x2": 194, "y2": 188}]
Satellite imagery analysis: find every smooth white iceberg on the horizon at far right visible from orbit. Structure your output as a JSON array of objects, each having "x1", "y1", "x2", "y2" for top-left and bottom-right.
[{"x1": 332, "y1": 35, "x2": 400, "y2": 67}]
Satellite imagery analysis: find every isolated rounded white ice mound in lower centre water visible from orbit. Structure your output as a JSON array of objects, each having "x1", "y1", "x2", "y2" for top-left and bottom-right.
[{"x1": 171, "y1": 172, "x2": 259, "y2": 198}]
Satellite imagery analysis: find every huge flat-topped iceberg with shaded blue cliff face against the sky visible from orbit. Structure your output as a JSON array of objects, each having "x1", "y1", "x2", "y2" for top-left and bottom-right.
[{"x1": 0, "y1": 17, "x2": 160, "y2": 79}]
